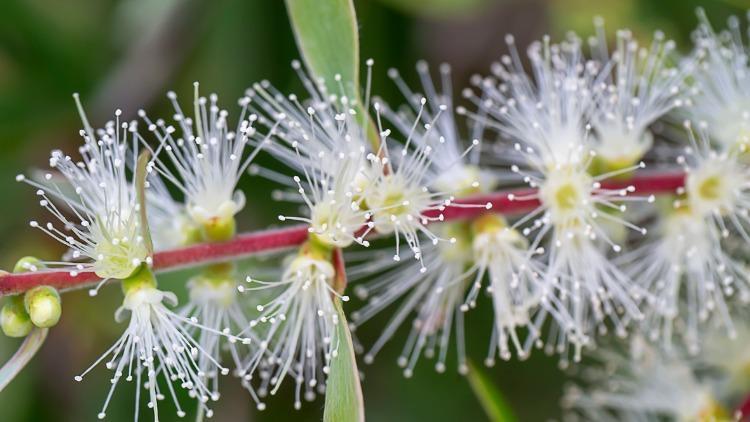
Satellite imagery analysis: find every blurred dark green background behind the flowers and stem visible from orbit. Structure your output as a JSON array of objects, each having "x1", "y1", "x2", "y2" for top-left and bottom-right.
[{"x1": 0, "y1": 0, "x2": 750, "y2": 421}]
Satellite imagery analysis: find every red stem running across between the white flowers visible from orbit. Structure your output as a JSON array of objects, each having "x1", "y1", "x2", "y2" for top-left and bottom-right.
[{"x1": 0, "y1": 172, "x2": 685, "y2": 296}]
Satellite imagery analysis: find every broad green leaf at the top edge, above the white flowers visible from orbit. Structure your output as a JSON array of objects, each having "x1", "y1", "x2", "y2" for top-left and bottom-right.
[{"x1": 286, "y1": 0, "x2": 359, "y2": 98}]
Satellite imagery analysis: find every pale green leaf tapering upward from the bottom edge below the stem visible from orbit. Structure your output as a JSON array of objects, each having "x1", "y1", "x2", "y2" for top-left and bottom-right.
[{"x1": 323, "y1": 298, "x2": 365, "y2": 422}]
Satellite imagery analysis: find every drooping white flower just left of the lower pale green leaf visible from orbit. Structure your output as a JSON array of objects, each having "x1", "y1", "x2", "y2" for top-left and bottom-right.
[{"x1": 241, "y1": 254, "x2": 349, "y2": 409}]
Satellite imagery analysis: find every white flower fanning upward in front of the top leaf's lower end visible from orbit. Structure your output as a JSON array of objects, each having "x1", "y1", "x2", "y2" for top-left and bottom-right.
[{"x1": 248, "y1": 61, "x2": 372, "y2": 247}]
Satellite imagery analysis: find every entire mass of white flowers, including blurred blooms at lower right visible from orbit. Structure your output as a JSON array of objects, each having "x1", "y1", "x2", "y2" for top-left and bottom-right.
[{"x1": 4, "y1": 6, "x2": 750, "y2": 420}]
